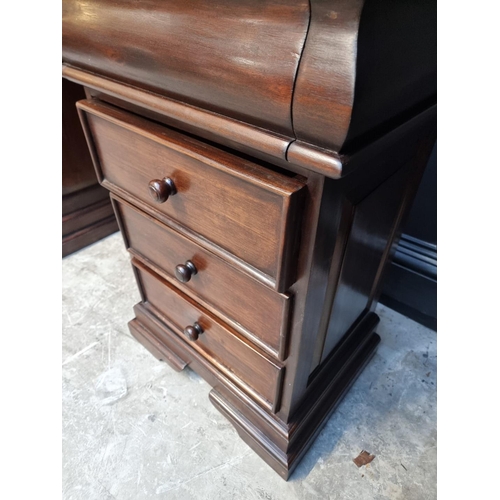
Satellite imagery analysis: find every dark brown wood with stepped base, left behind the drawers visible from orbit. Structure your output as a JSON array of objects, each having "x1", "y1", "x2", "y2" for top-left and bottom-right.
[{"x1": 62, "y1": 79, "x2": 118, "y2": 257}]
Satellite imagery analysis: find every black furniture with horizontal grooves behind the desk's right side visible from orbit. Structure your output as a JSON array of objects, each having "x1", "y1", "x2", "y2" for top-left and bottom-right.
[{"x1": 380, "y1": 146, "x2": 437, "y2": 330}]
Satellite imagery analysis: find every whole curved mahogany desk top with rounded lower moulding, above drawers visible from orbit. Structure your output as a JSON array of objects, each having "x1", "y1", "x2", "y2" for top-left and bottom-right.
[{"x1": 63, "y1": 0, "x2": 436, "y2": 178}]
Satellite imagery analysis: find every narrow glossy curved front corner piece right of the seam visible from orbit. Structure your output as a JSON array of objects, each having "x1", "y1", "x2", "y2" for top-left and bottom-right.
[{"x1": 292, "y1": 0, "x2": 363, "y2": 151}]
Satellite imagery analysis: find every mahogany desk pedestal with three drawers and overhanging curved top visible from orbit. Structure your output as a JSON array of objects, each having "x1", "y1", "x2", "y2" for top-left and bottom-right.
[{"x1": 63, "y1": 0, "x2": 436, "y2": 479}]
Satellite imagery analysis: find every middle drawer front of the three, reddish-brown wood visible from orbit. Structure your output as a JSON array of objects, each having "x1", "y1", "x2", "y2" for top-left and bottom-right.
[{"x1": 112, "y1": 196, "x2": 290, "y2": 359}]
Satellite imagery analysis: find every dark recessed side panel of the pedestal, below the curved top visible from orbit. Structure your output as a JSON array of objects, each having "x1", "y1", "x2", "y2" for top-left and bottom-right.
[{"x1": 311, "y1": 108, "x2": 436, "y2": 372}]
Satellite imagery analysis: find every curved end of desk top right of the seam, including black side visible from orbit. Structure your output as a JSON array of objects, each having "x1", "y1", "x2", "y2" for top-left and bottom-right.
[{"x1": 292, "y1": 0, "x2": 436, "y2": 154}]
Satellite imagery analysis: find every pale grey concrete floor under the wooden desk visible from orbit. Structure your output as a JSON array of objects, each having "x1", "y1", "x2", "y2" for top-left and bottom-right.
[{"x1": 63, "y1": 234, "x2": 436, "y2": 500}]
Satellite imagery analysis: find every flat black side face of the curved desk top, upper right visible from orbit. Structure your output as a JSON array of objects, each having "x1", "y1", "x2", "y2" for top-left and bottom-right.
[{"x1": 343, "y1": 0, "x2": 437, "y2": 152}]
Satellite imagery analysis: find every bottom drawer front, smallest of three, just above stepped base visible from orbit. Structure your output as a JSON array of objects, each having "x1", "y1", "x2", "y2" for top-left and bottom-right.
[{"x1": 132, "y1": 260, "x2": 283, "y2": 409}]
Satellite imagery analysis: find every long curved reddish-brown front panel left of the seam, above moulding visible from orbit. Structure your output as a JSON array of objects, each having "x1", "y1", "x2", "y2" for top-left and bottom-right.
[{"x1": 62, "y1": 0, "x2": 309, "y2": 133}]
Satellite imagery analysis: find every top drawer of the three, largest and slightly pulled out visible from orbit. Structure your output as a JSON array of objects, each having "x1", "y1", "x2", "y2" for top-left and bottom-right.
[{"x1": 77, "y1": 101, "x2": 304, "y2": 292}]
